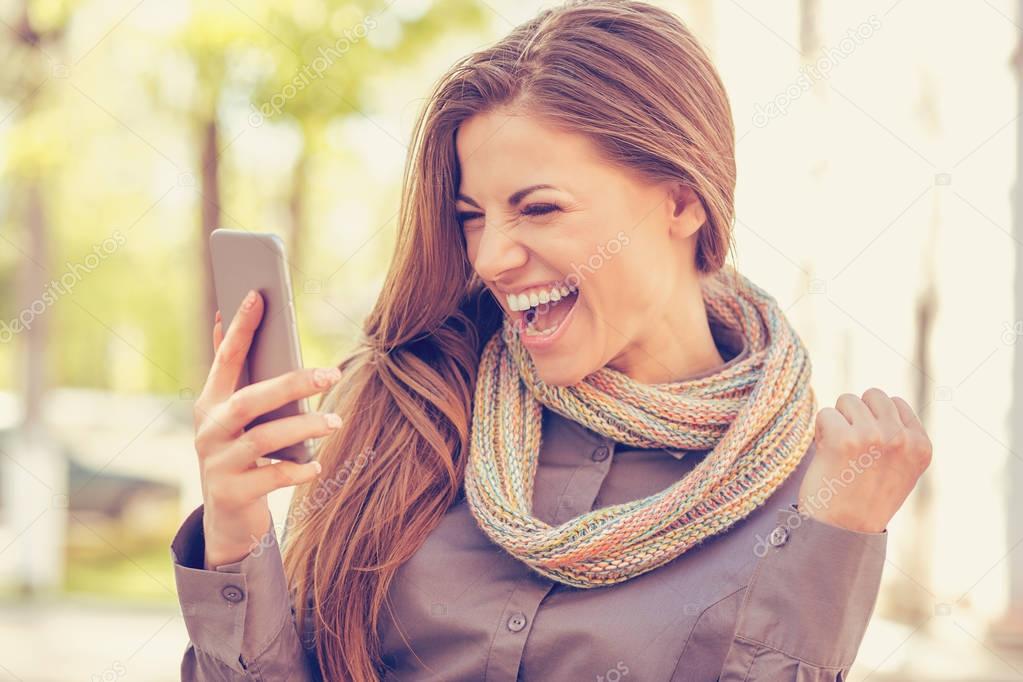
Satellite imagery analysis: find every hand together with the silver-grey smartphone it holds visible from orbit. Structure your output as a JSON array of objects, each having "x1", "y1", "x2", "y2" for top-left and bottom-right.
[{"x1": 194, "y1": 229, "x2": 341, "y2": 567}]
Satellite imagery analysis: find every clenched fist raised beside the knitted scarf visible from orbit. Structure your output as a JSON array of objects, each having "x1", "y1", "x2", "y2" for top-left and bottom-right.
[{"x1": 799, "y1": 389, "x2": 931, "y2": 533}]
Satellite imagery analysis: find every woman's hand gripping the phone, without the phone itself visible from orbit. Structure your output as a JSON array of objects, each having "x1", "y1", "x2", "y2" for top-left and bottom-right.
[{"x1": 193, "y1": 290, "x2": 342, "y2": 569}]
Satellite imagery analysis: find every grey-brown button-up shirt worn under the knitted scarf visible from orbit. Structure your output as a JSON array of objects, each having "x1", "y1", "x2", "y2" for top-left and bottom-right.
[{"x1": 171, "y1": 400, "x2": 888, "y2": 682}]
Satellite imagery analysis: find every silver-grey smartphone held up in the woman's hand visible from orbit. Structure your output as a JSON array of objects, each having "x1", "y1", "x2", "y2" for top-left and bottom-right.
[{"x1": 210, "y1": 228, "x2": 313, "y2": 464}]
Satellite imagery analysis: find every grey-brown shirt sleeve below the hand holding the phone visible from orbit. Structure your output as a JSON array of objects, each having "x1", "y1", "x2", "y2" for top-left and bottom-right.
[{"x1": 171, "y1": 505, "x2": 320, "y2": 682}]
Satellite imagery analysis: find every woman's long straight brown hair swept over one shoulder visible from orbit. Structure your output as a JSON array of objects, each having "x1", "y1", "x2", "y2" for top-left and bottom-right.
[{"x1": 283, "y1": 0, "x2": 736, "y2": 681}]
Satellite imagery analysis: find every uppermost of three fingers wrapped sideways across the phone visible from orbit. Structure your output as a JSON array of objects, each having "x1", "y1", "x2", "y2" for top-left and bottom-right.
[{"x1": 214, "y1": 366, "x2": 341, "y2": 433}]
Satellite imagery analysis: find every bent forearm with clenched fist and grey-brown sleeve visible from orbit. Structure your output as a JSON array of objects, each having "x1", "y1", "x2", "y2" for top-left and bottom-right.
[{"x1": 720, "y1": 388, "x2": 932, "y2": 682}]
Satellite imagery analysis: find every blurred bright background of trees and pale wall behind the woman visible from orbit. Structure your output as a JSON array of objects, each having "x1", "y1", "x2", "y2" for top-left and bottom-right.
[{"x1": 0, "y1": 0, "x2": 1023, "y2": 681}]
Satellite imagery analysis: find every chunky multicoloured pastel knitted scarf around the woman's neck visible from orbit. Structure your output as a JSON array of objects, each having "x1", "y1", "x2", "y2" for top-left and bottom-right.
[{"x1": 464, "y1": 267, "x2": 816, "y2": 588}]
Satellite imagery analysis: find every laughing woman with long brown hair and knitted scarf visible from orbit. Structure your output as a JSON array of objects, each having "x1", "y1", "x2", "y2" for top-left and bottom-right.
[{"x1": 172, "y1": 0, "x2": 931, "y2": 682}]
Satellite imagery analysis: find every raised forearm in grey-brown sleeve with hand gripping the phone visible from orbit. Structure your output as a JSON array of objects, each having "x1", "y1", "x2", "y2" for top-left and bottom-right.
[{"x1": 171, "y1": 291, "x2": 342, "y2": 680}]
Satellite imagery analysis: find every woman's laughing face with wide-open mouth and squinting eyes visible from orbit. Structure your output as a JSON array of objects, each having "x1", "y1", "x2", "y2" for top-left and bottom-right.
[{"x1": 455, "y1": 105, "x2": 706, "y2": 385}]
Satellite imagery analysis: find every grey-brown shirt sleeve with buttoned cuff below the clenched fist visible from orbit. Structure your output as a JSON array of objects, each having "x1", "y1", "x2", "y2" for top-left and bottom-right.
[{"x1": 719, "y1": 504, "x2": 888, "y2": 682}]
